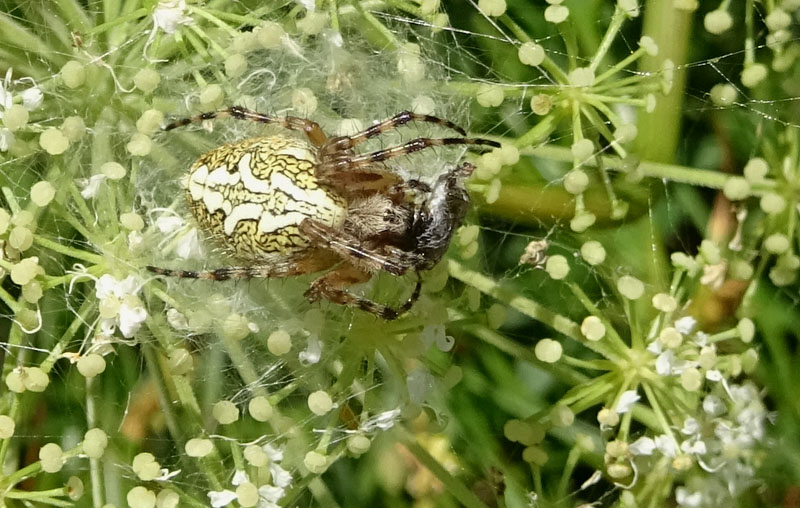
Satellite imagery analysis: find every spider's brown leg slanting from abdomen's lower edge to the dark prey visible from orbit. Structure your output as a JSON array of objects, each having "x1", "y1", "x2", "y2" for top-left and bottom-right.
[{"x1": 300, "y1": 219, "x2": 413, "y2": 275}]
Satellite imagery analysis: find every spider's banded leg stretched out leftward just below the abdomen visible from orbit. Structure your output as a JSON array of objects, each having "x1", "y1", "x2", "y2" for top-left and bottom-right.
[{"x1": 146, "y1": 251, "x2": 336, "y2": 281}]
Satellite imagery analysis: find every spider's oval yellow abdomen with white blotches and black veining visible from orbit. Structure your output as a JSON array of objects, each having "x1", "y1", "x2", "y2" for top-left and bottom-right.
[{"x1": 184, "y1": 136, "x2": 347, "y2": 260}]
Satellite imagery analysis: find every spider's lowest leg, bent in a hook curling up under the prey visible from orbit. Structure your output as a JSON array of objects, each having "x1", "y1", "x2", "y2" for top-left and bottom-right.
[{"x1": 305, "y1": 263, "x2": 422, "y2": 321}]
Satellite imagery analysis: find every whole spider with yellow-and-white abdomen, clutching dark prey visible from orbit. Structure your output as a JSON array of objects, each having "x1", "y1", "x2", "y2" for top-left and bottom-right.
[{"x1": 147, "y1": 106, "x2": 500, "y2": 320}]
